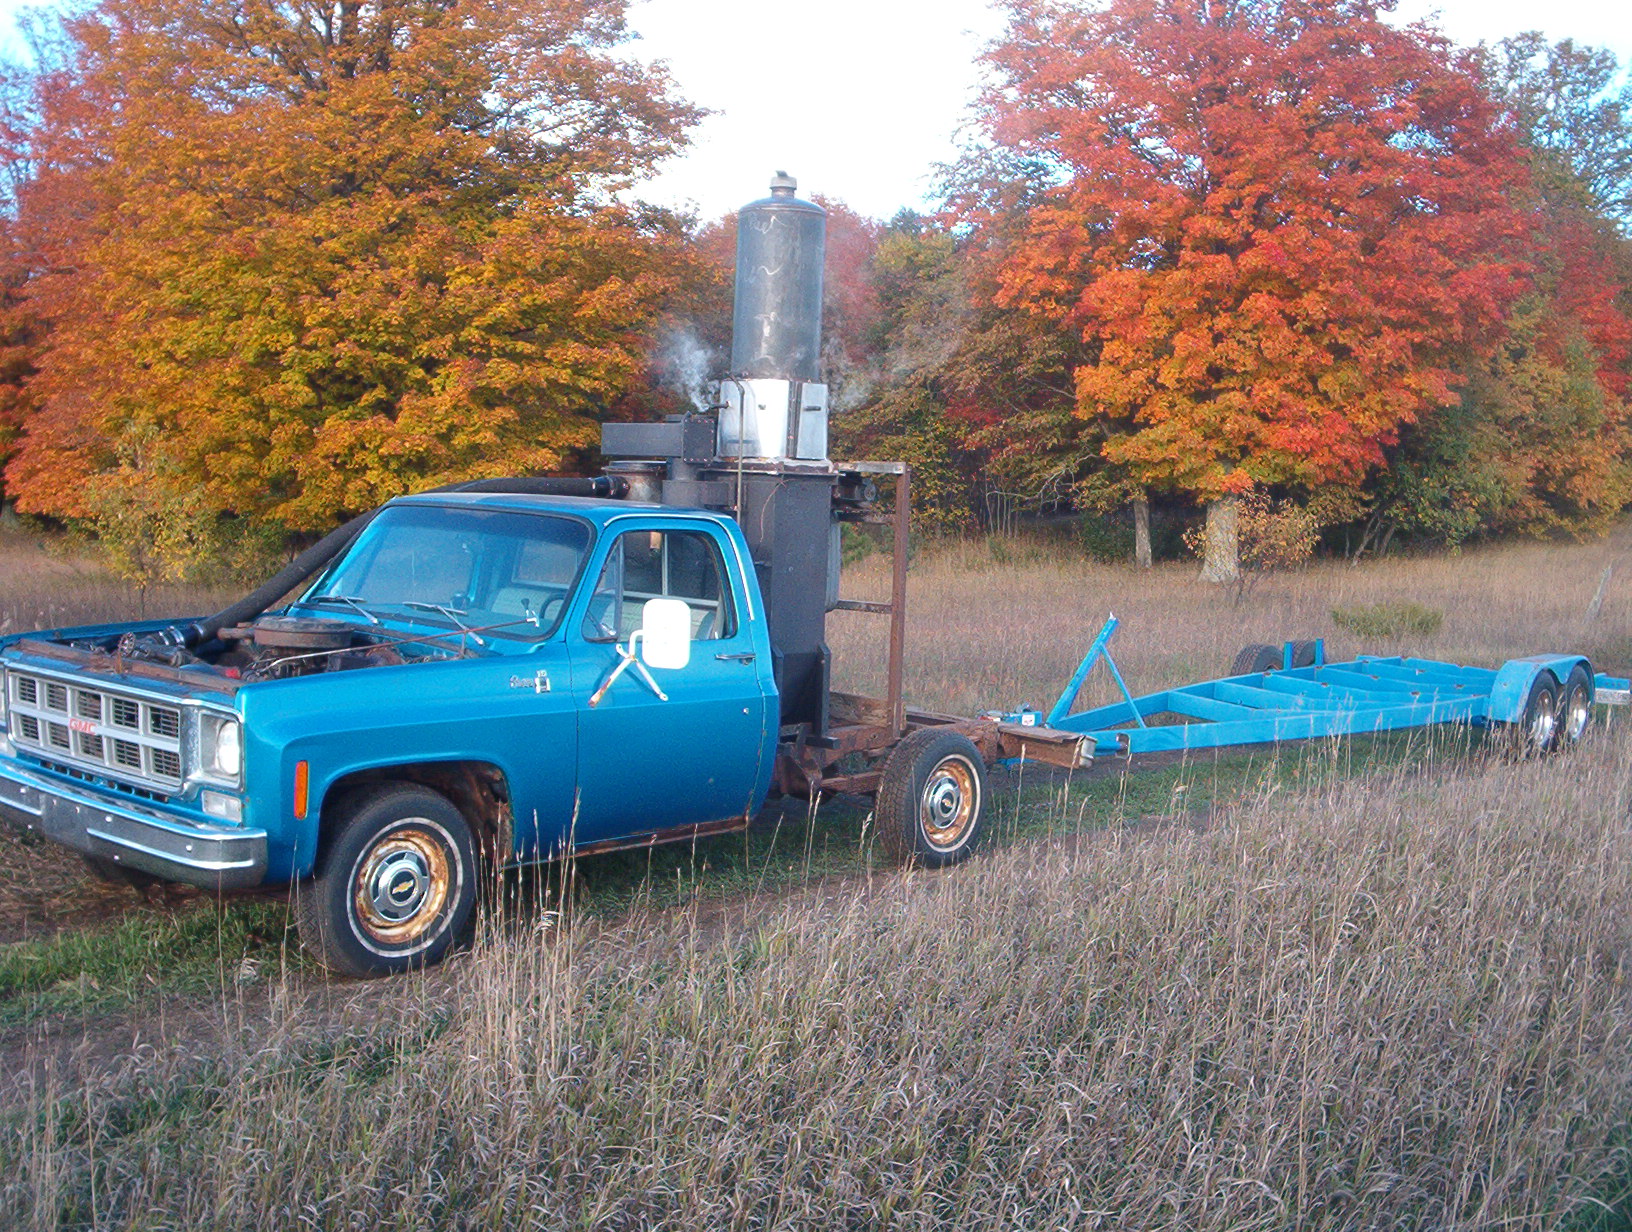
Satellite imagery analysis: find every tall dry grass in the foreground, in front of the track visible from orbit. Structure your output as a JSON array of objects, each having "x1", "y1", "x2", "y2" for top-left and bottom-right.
[{"x1": 9, "y1": 733, "x2": 1632, "y2": 1232}]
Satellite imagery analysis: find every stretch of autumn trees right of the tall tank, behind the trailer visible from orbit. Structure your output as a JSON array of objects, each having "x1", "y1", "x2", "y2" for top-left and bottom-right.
[{"x1": 806, "y1": 10, "x2": 1632, "y2": 576}]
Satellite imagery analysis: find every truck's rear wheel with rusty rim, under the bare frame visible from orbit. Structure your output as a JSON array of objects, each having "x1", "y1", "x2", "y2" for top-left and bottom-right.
[{"x1": 873, "y1": 728, "x2": 986, "y2": 868}]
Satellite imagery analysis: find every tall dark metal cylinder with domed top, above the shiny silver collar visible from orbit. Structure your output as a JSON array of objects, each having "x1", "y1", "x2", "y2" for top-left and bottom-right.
[{"x1": 731, "y1": 171, "x2": 827, "y2": 380}]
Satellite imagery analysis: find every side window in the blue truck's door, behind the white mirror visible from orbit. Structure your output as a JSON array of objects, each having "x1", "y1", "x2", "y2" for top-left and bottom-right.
[{"x1": 584, "y1": 530, "x2": 736, "y2": 641}]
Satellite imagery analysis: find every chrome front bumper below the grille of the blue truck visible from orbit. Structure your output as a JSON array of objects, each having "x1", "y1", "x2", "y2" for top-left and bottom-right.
[{"x1": 0, "y1": 760, "x2": 266, "y2": 889}]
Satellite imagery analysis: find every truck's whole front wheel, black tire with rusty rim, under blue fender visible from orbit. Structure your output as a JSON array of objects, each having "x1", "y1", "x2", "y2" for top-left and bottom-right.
[{"x1": 295, "y1": 785, "x2": 477, "y2": 976}]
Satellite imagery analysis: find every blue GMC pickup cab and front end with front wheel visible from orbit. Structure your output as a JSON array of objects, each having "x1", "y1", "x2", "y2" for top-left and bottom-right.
[{"x1": 0, "y1": 493, "x2": 778, "y2": 974}]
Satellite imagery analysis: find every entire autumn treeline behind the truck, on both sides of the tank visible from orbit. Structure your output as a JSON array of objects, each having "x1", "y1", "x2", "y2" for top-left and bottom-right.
[{"x1": 0, "y1": 0, "x2": 1632, "y2": 576}]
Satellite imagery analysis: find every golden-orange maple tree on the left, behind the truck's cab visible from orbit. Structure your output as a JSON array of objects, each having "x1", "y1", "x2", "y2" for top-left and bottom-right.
[{"x1": 7, "y1": 0, "x2": 697, "y2": 530}]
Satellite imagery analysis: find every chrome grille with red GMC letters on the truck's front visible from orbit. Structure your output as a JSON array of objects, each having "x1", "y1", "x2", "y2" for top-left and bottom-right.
[{"x1": 7, "y1": 671, "x2": 183, "y2": 791}]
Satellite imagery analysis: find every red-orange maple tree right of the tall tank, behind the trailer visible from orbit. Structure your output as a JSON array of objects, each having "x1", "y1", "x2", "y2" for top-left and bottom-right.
[{"x1": 960, "y1": 0, "x2": 1523, "y2": 569}]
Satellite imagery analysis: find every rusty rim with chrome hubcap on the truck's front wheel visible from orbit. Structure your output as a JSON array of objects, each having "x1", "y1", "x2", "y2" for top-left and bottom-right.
[{"x1": 351, "y1": 818, "x2": 452, "y2": 953}]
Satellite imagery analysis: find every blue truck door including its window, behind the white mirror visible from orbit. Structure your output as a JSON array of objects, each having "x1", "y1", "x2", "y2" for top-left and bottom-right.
[{"x1": 568, "y1": 524, "x2": 775, "y2": 847}]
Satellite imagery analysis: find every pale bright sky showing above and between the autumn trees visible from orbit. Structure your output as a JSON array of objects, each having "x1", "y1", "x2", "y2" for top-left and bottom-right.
[{"x1": 0, "y1": 0, "x2": 1632, "y2": 219}]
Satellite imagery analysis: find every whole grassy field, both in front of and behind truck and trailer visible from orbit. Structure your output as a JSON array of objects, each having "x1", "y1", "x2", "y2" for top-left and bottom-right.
[{"x1": 0, "y1": 532, "x2": 1632, "y2": 1229}]
